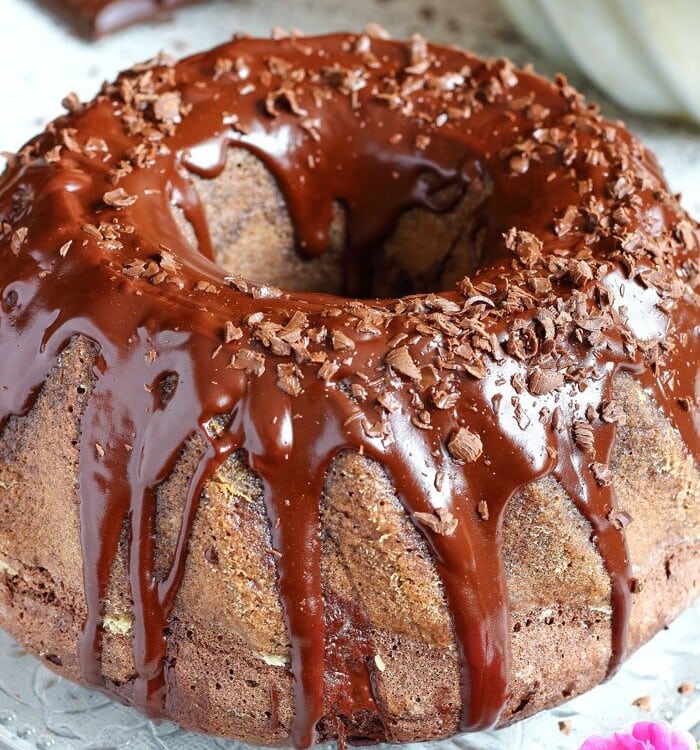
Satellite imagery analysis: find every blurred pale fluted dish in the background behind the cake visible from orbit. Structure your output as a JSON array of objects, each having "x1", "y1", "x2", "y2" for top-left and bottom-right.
[{"x1": 504, "y1": 0, "x2": 700, "y2": 122}]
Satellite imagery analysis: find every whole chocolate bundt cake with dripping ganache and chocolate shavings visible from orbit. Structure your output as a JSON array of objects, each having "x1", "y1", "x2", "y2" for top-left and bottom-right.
[{"x1": 0, "y1": 28, "x2": 700, "y2": 747}]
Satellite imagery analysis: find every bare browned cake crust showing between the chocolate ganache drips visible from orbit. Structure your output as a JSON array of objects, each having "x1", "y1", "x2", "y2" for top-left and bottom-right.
[{"x1": 0, "y1": 27, "x2": 700, "y2": 744}]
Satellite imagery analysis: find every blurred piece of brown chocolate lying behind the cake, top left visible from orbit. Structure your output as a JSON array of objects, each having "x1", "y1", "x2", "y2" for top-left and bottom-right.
[{"x1": 33, "y1": 0, "x2": 200, "y2": 39}]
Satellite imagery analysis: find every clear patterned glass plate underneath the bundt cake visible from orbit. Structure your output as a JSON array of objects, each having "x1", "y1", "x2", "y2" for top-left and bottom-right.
[{"x1": 0, "y1": 600, "x2": 700, "y2": 750}]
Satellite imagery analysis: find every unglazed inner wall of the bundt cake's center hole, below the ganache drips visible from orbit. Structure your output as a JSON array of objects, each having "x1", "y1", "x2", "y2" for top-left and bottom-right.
[{"x1": 174, "y1": 149, "x2": 480, "y2": 297}]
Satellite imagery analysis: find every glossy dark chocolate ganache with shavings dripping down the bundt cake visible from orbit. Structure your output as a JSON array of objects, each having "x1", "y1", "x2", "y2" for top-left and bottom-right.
[{"x1": 0, "y1": 29, "x2": 700, "y2": 747}]
